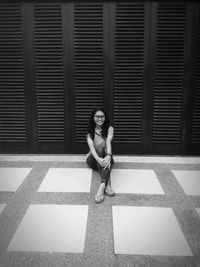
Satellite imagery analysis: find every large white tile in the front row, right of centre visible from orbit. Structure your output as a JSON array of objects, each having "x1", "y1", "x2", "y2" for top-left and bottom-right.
[{"x1": 113, "y1": 206, "x2": 192, "y2": 256}]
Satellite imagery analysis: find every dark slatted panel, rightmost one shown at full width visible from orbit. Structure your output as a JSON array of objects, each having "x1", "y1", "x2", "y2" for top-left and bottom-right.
[{"x1": 153, "y1": 2, "x2": 186, "y2": 144}]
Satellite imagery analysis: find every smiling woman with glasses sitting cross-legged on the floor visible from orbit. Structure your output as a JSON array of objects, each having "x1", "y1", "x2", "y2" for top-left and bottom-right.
[{"x1": 86, "y1": 108, "x2": 115, "y2": 203}]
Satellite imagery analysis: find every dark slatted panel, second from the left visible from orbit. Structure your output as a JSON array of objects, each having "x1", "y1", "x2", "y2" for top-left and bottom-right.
[{"x1": 34, "y1": 3, "x2": 64, "y2": 143}]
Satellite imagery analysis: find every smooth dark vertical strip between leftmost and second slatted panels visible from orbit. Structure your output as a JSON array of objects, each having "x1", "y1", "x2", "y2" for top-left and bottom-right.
[{"x1": 21, "y1": 3, "x2": 38, "y2": 153}]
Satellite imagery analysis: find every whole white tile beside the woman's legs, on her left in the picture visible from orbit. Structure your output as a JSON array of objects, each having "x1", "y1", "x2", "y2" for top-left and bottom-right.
[{"x1": 38, "y1": 168, "x2": 92, "y2": 192}]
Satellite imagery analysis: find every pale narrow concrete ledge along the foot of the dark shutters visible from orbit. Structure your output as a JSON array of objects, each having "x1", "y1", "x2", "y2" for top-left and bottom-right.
[{"x1": 0, "y1": 154, "x2": 200, "y2": 164}]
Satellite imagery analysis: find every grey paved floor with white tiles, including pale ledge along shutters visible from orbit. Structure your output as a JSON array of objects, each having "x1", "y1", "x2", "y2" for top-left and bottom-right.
[{"x1": 0, "y1": 155, "x2": 200, "y2": 267}]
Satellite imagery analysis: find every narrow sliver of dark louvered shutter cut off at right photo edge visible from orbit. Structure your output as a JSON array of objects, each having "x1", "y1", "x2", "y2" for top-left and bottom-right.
[{"x1": 190, "y1": 5, "x2": 200, "y2": 154}]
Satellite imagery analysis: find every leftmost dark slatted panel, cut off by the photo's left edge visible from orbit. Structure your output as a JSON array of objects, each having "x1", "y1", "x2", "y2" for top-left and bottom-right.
[{"x1": 0, "y1": 4, "x2": 27, "y2": 142}]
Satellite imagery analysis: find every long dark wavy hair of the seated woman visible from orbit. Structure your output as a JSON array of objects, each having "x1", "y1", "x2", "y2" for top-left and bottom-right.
[{"x1": 87, "y1": 108, "x2": 110, "y2": 140}]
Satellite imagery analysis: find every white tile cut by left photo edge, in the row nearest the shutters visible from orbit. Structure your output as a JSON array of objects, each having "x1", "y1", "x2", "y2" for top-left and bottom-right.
[{"x1": 0, "y1": 168, "x2": 31, "y2": 191}]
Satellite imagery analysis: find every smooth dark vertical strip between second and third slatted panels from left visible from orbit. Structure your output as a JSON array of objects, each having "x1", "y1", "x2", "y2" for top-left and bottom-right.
[{"x1": 62, "y1": 3, "x2": 74, "y2": 153}]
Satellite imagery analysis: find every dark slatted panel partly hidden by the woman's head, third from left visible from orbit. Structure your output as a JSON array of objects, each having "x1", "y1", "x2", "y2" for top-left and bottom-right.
[{"x1": 74, "y1": 3, "x2": 104, "y2": 143}]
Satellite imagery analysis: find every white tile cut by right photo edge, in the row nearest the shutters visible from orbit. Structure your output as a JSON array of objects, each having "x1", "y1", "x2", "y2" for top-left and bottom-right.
[{"x1": 172, "y1": 170, "x2": 200, "y2": 196}]
